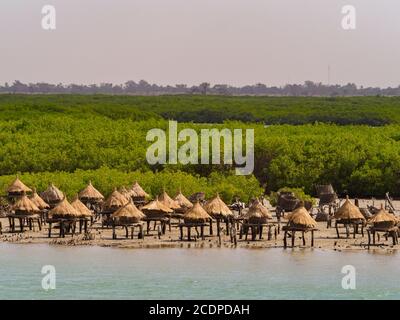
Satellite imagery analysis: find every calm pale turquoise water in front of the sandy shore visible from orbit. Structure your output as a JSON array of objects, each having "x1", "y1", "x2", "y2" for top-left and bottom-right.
[{"x1": 0, "y1": 244, "x2": 400, "y2": 299}]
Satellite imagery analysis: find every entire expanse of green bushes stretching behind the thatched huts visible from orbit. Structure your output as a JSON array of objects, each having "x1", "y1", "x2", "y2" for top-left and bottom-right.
[{"x1": 0, "y1": 95, "x2": 400, "y2": 201}]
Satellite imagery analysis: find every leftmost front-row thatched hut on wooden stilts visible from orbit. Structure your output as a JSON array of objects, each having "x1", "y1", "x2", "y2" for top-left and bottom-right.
[{"x1": 8, "y1": 194, "x2": 42, "y2": 232}]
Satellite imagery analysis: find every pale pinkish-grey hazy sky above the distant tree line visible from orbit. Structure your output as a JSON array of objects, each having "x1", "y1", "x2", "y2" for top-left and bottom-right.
[{"x1": 0, "y1": 0, "x2": 400, "y2": 86}]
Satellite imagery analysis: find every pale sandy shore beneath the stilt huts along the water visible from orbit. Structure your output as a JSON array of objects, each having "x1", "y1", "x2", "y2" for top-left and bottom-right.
[{"x1": 0, "y1": 200, "x2": 400, "y2": 251}]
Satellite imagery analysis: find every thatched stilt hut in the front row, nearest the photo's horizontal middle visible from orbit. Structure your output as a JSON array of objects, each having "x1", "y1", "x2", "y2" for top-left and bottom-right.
[{"x1": 179, "y1": 201, "x2": 212, "y2": 241}]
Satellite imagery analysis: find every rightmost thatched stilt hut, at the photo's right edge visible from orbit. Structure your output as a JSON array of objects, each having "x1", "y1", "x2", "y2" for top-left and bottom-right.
[{"x1": 367, "y1": 205, "x2": 399, "y2": 248}]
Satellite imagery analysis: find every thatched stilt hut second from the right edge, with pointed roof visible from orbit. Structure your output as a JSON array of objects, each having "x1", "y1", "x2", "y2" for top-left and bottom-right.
[{"x1": 334, "y1": 197, "x2": 365, "y2": 238}]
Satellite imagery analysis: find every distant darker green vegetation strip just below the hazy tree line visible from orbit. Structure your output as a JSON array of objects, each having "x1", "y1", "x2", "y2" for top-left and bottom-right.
[{"x1": 0, "y1": 95, "x2": 400, "y2": 126}]
